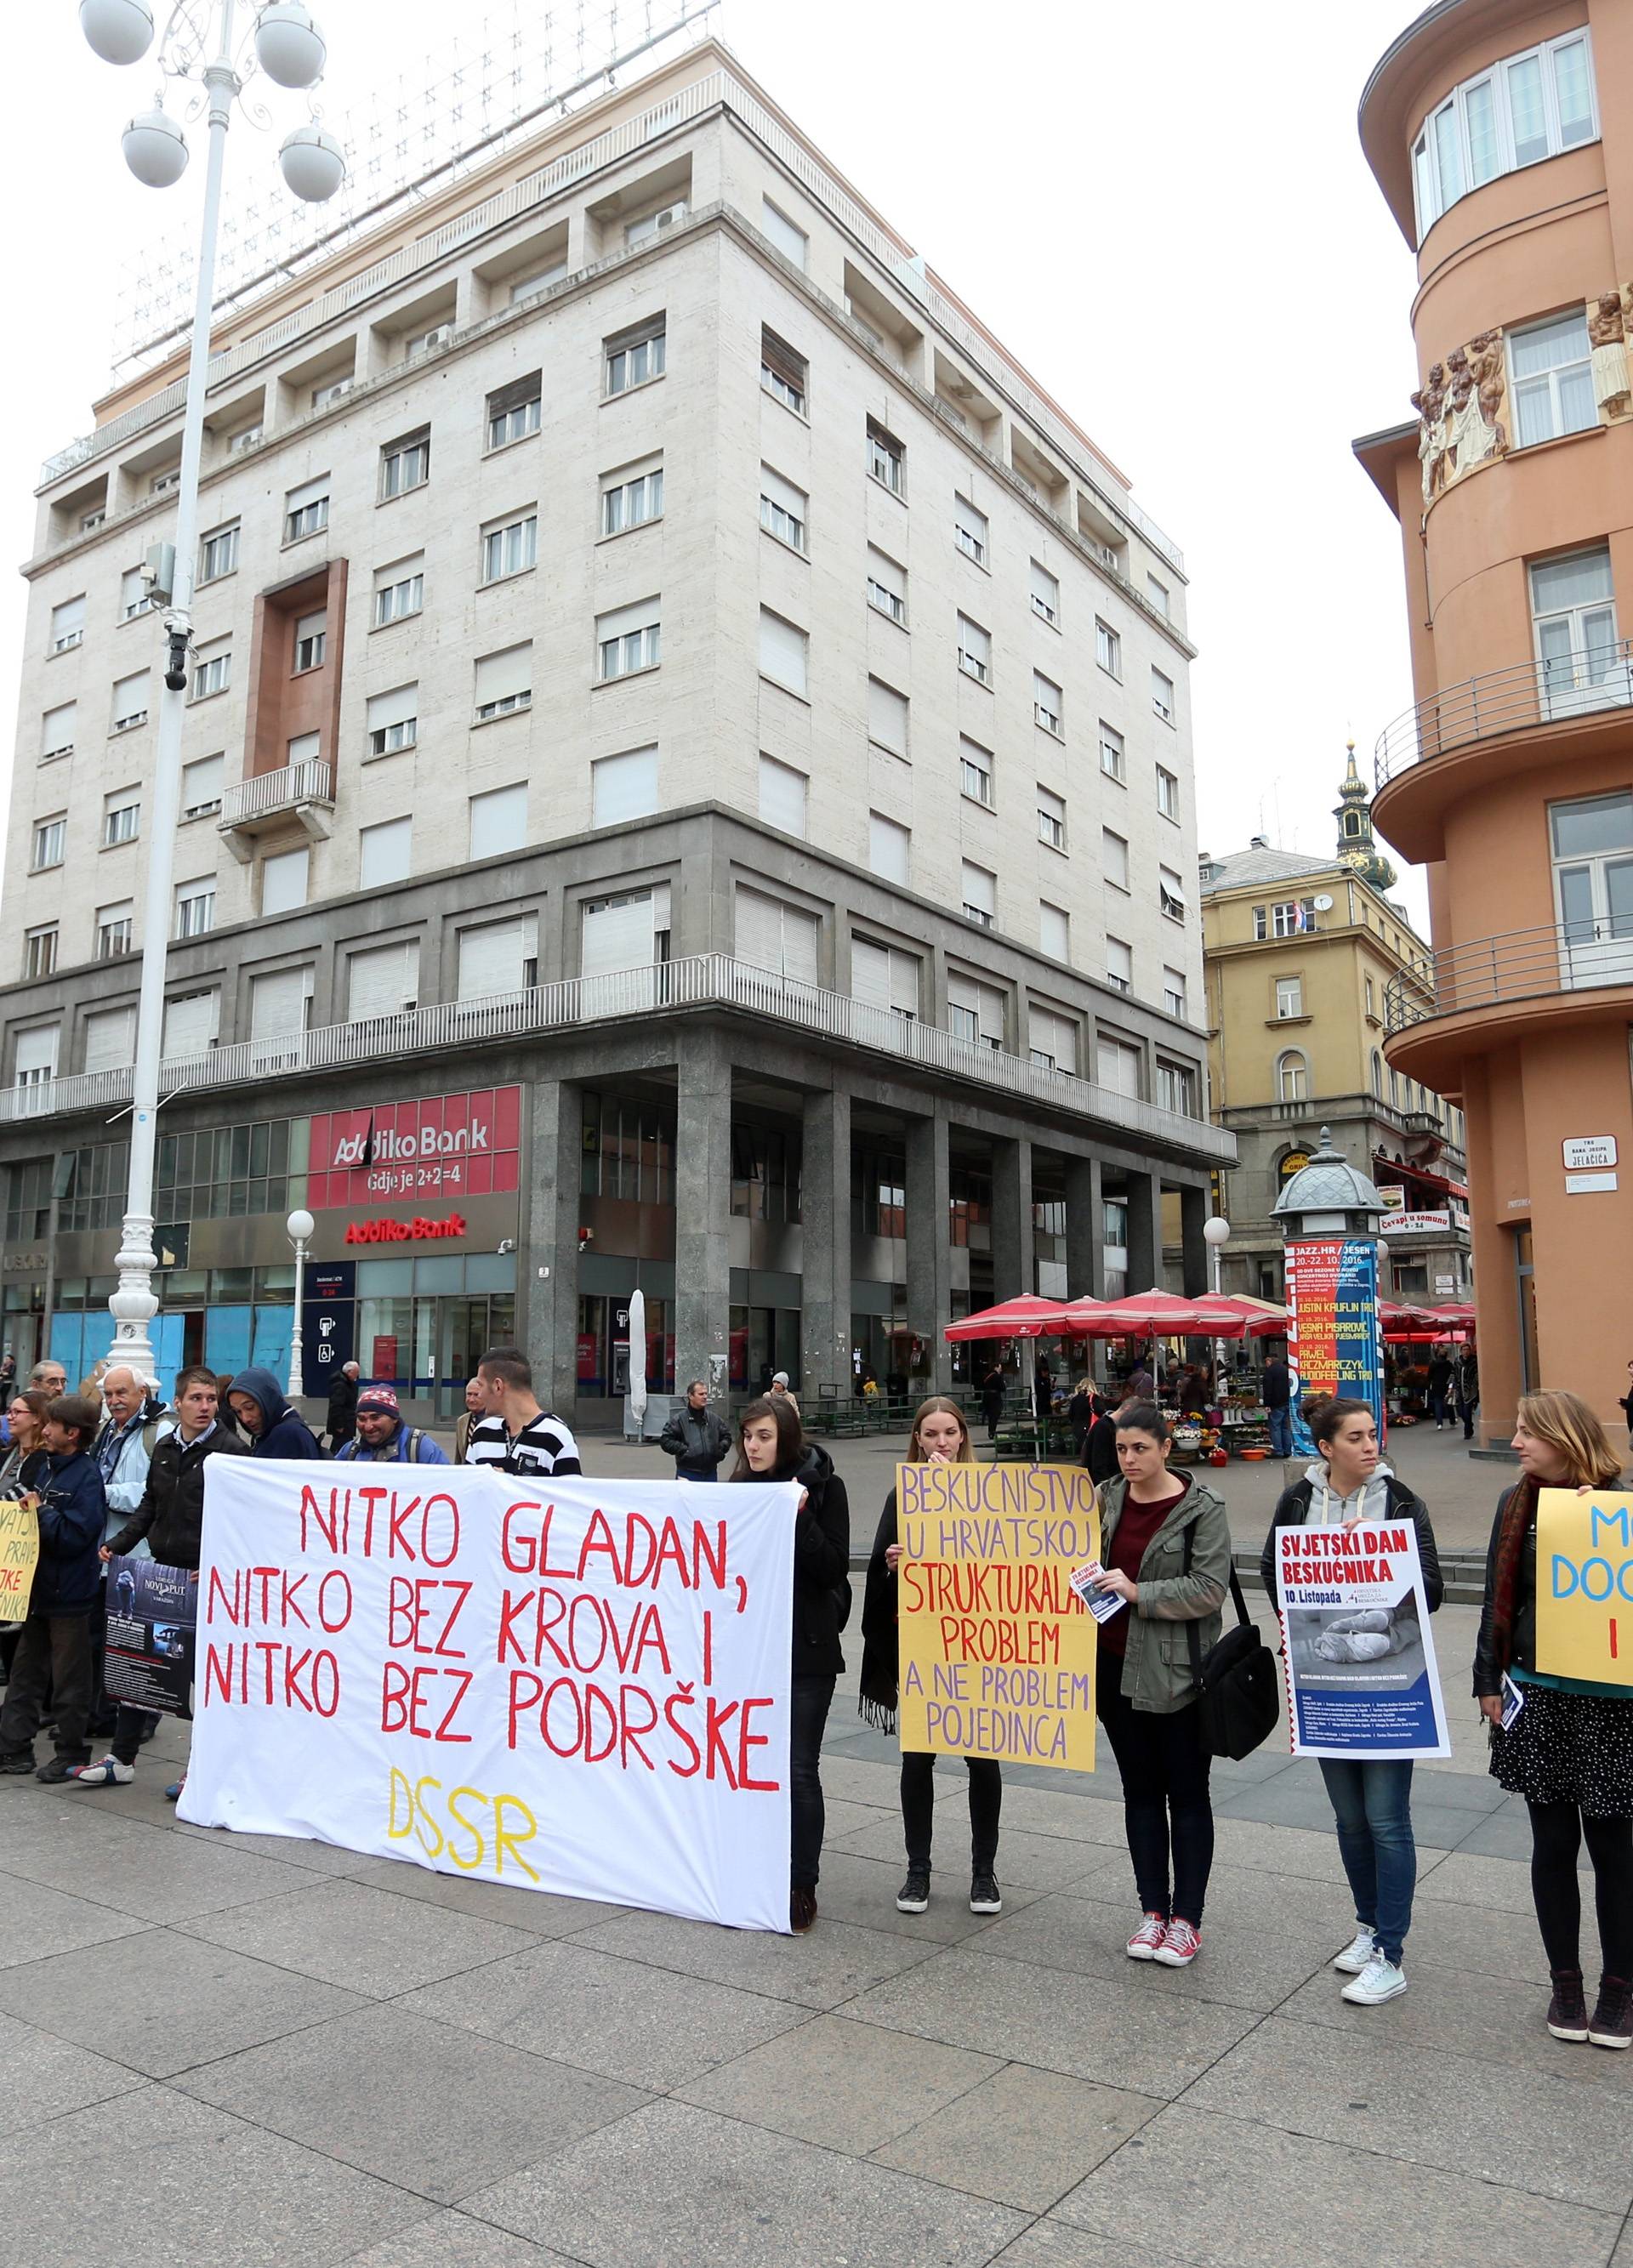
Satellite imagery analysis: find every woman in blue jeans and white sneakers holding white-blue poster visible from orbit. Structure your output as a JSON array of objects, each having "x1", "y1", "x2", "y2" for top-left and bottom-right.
[{"x1": 1259, "y1": 1400, "x2": 1442, "y2": 2007}]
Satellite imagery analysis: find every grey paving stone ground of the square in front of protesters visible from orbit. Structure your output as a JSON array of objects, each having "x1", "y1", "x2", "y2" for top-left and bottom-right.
[{"x1": 0, "y1": 1651, "x2": 1633, "y2": 2268}]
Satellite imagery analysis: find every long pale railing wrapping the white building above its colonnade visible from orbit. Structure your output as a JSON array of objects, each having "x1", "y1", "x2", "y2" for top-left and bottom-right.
[{"x1": 0, "y1": 952, "x2": 1236, "y2": 1166}]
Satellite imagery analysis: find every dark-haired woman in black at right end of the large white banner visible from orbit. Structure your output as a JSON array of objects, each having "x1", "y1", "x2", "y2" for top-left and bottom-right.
[{"x1": 732, "y1": 1395, "x2": 851, "y2": 1935}]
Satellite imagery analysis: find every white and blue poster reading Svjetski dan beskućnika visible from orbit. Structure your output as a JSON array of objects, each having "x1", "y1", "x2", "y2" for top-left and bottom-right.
[{"x1": 1275, "y1": 1520, "x2": 1452, "y2": 1762}]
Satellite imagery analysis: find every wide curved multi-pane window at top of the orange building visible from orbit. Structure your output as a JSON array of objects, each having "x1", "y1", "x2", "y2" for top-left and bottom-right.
[{"x1": 1413, "y1": 30, "x2": 1599, "y2": 242}]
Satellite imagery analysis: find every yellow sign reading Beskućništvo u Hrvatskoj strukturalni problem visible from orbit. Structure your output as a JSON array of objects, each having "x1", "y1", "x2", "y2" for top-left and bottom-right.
[{"x1": 896, "y1": 1465, "x2": 1100, "y2": 1771}]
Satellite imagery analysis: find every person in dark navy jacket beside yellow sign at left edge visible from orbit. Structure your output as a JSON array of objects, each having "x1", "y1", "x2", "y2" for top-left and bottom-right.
[{"x1": 0, "y1": 1395, "x2": 106, "y2": 1782}]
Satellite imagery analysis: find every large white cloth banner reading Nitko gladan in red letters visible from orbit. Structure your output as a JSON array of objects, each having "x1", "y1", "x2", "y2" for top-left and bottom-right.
[{"x1": 179, "y1": 1456, "x2": 796, "y2": 1930}]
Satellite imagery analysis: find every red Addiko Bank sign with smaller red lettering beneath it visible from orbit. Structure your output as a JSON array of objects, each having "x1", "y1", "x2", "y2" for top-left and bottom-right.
[{"x1": 306, "y1": 1086, "x2": 521, "y2": 1215}]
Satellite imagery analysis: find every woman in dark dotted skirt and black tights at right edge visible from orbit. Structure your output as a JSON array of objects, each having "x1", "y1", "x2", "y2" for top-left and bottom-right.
[{"x1": 1474, "y1": 1393, "x2": 1633, "y2": 2048}]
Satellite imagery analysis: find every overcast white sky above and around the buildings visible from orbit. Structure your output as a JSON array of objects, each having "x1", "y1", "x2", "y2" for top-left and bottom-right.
[{"x1": 0, "y1": 0, "x2": 1425, "y2": 918}]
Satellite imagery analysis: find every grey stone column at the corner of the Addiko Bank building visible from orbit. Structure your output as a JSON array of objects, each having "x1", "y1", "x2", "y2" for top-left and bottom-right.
[{"x1": 676, "y1": 1030, "x2": 731, "y2": 1400}]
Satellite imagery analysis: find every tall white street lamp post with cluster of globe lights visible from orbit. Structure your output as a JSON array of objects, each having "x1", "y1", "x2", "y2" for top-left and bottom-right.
[{"x1": 79, "y1": 0, "x2": 344, "y2": 1374}]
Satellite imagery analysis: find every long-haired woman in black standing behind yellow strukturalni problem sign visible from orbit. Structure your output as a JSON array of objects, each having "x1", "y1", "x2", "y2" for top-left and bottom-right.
[{"x1": 860, "y1": 1395, "x2": 1003, "y2": 1914}]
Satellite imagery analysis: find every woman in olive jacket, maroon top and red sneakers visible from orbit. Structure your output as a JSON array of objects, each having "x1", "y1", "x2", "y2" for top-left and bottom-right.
[{"x1": 1093, "y1": 1401, "x2": 1232, "y2": 1969}]
